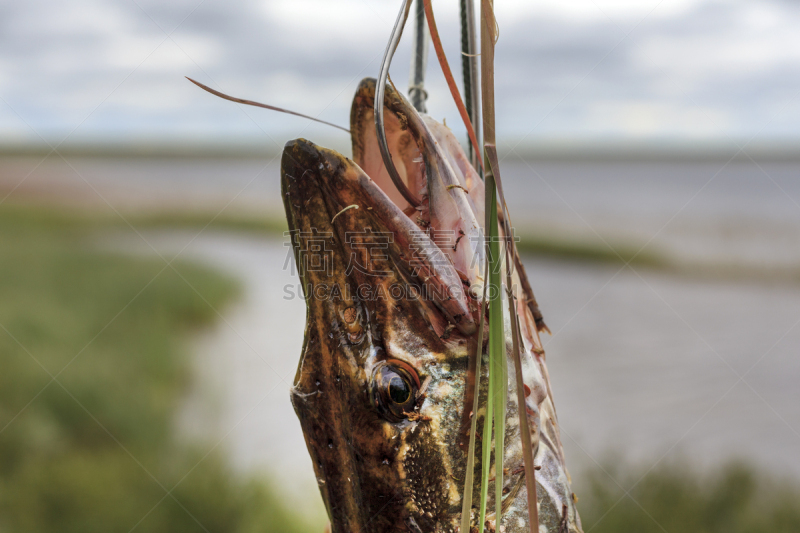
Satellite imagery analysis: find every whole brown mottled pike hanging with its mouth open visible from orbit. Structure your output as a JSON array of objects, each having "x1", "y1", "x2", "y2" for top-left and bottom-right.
[{"x1": 281, "y1": 79, "x2": 581, "y2": 533}]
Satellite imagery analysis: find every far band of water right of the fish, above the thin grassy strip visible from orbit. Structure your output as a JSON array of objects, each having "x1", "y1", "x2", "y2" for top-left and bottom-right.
[{"x1": 503, "y1": 158, "x2": 800, "y2": 267}]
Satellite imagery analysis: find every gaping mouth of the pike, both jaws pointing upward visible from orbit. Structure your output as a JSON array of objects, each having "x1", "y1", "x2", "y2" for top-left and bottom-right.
[{"x1": 281, "y1": 79, "x2": 483, "y2": 336}]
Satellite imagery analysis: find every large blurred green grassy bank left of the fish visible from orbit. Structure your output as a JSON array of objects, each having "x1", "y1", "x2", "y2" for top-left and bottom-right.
[{"x1": 0, "y1": 204, "x2": 305, "y2": 533}]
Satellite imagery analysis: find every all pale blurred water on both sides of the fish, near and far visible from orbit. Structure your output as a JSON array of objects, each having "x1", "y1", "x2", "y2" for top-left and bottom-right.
[{"x1": 25, "y1": 154, "x2": 800, "y2": 505}]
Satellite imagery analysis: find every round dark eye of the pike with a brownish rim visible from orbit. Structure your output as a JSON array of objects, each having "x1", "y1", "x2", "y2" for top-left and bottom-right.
[{"x1": 370, "y1": 360, "x2": 419, "y2": 422}]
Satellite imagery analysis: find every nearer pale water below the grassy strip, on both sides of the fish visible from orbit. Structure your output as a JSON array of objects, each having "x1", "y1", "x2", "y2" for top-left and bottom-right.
[{"x1": 114, "y1": 232, "x2": 800, "y2": 510}]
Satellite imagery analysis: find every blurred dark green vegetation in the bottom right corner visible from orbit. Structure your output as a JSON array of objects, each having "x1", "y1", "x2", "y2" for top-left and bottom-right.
[{"x1": 578, "y1": 463, "x2": 800, "y2": 533}]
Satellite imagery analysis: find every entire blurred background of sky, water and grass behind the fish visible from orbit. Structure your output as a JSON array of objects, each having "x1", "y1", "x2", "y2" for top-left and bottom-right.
[{"x1": 0, "y1": 0, "x2": 800, "y2": 533}]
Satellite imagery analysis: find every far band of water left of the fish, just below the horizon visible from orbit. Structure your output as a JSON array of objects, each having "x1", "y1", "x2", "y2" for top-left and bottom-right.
[{"x1": 0, "y1": 155, "x2": 282, "y2": 214}]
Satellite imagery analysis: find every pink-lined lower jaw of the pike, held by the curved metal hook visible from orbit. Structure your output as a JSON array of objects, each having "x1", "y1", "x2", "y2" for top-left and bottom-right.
[{"x1": 350, "y1": 78, "x2": 484, "y2": 290}]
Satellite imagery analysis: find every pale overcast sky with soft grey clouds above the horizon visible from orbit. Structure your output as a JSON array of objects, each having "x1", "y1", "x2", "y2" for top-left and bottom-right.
[{"x1": 0, "y1": 0, "x2": 800, "y2": 149}]
